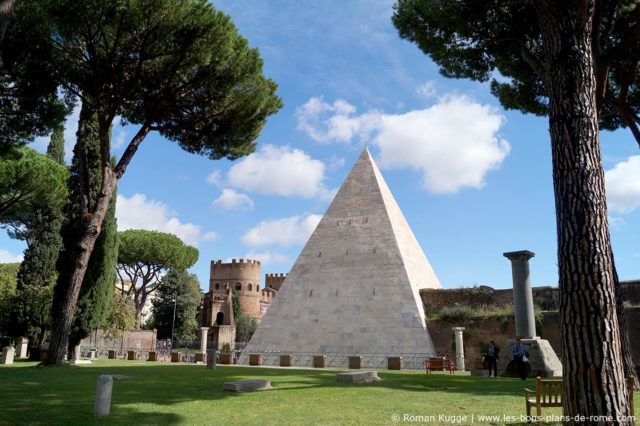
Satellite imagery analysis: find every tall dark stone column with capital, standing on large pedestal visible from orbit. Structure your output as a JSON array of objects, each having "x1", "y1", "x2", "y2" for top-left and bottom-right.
[{"x1": 503, "y1": 250, "x2": 536, "y2": 339}]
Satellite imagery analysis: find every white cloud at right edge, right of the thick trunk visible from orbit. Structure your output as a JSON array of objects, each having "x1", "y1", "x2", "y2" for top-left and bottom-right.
[{"x1": 605, "y1": 155, "x2": 640, "y2": 213}]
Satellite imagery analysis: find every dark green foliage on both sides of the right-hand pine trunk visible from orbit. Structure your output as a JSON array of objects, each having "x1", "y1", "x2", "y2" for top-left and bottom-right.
[{"x1": 393, "y1": 0, "x2": 640, "y2": 146}]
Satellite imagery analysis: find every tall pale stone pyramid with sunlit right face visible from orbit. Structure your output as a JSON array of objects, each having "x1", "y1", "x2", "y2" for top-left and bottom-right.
[{"x1": 243, "y1": 148, "x2": 440, "y2": 362}]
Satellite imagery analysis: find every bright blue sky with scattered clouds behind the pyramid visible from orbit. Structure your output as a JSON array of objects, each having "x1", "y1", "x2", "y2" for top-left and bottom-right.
[{"x1": 0, "y1": 0, "x2": 640, "y2": 289}]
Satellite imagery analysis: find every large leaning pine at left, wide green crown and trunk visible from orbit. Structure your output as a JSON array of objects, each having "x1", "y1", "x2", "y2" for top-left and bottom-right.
[{"x1": 4, "y1": 0, "x2": 281, "y2": 363}]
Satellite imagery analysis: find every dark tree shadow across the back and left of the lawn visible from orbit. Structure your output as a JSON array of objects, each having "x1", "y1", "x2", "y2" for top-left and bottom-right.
[{"x1": 0, "y1": 361, "x2": 533, "y2": 424}]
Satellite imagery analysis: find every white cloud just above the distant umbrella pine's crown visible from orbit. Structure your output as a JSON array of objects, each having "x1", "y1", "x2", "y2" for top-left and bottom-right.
[{"x1": 116, "y1": 194, "x2": 217, "y2": 246}]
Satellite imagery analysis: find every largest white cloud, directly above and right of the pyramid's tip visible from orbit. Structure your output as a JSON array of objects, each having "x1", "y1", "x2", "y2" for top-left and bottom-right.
[{"x1": 297, "y1": 95, "x2": 511, "y2": 193}]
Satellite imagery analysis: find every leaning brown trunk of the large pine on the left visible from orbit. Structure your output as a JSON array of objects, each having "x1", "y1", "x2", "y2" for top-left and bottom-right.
[{"x1": 46, "y1": 171, "x2": 117, "y2": 364}]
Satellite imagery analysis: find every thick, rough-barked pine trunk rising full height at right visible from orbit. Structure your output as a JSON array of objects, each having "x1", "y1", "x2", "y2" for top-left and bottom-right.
[{"x1": 535, "y1": 0, "x2": 633, "y2": 424}]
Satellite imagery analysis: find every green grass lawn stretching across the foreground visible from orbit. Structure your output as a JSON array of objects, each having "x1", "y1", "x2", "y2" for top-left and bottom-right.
[{"x1": 0, "y1": 360, "x2": 620, "y2": 425}]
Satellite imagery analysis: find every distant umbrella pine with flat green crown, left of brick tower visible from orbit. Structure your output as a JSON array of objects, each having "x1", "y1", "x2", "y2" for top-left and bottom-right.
[{"x1": 117, "y1": 229, "x2": 198, "y2": 326}]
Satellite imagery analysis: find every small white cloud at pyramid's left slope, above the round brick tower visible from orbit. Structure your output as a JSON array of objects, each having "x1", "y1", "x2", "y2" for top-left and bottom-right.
[{"x1": 242, "y1": 214, "x2": 322, "y2": 247}]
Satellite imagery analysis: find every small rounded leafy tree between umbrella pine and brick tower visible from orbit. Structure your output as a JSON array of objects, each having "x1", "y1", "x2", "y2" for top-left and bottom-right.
[{"x1": 152, "y1": 270, "x2": 201, "y2": 342}]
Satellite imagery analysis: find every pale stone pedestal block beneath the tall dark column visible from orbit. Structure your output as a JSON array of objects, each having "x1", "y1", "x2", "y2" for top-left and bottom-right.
[{"x1": 498, "y1": 338, "x2": 562, "y2": 377}]
